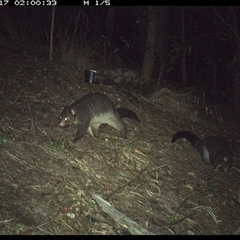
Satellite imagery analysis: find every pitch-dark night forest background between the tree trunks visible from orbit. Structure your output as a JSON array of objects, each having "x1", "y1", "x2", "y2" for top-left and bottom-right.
[{"x1": 0, "y1": 6, "x2": 239, "y2": 104}]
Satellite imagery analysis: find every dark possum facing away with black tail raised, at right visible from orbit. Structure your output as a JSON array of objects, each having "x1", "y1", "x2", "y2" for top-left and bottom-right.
[{"x1": 172, "y1": 131, "x2": 233, "y2": 172}]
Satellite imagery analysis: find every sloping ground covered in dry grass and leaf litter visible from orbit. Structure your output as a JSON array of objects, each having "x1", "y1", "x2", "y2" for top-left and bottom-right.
[{"x1": 0, "y1": 49, "x2": 240, "y2": 235}]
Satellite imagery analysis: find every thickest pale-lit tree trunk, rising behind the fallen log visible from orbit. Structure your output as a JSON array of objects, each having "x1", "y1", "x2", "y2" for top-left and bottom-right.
[{"x1": 141, "y1": 6, "x2": 156, "y2": 90}]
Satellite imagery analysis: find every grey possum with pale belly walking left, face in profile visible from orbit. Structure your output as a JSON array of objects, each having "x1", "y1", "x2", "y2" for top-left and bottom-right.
[{"x1": 59, "y1": 92, "x2": 140, "y2": 143}]
